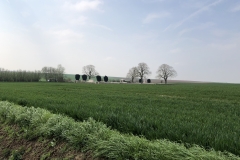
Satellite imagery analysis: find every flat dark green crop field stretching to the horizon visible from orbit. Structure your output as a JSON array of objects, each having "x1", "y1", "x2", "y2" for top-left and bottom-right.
[{"x1": 0, "y1": 82, "x2": 240, "y2": 155}]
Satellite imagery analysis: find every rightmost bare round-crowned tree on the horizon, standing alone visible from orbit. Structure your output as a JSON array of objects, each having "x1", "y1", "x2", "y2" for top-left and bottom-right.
[{"x1": 157, "y1": 64, "x2": 177, "y2": 84}]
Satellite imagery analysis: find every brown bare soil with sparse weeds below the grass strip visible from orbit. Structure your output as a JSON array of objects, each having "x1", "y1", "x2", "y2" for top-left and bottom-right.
[{"x1": 0, "y1": 125, "x2": 103, "y2": 160}]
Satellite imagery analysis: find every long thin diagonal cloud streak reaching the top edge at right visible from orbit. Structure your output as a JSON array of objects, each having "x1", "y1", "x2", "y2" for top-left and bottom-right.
[{"x1": 174, "y1": 0, "x2": 223, "y2": 29}]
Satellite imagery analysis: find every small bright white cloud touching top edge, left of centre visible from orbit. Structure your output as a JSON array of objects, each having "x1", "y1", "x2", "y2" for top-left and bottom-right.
[{"x1": 64, "y1": 0, "x2": 102, "y2": 12}]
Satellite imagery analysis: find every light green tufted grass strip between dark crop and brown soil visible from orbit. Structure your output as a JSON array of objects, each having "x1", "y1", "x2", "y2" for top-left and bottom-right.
[{"x1": 0, "y1": 102, "x2": 240, "y2": 160}]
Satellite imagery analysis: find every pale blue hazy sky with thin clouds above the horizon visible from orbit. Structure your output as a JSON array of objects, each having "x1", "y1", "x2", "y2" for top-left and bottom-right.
[{"x1": 0, "y1": 0, "x2": 240, "y2": 83}]
